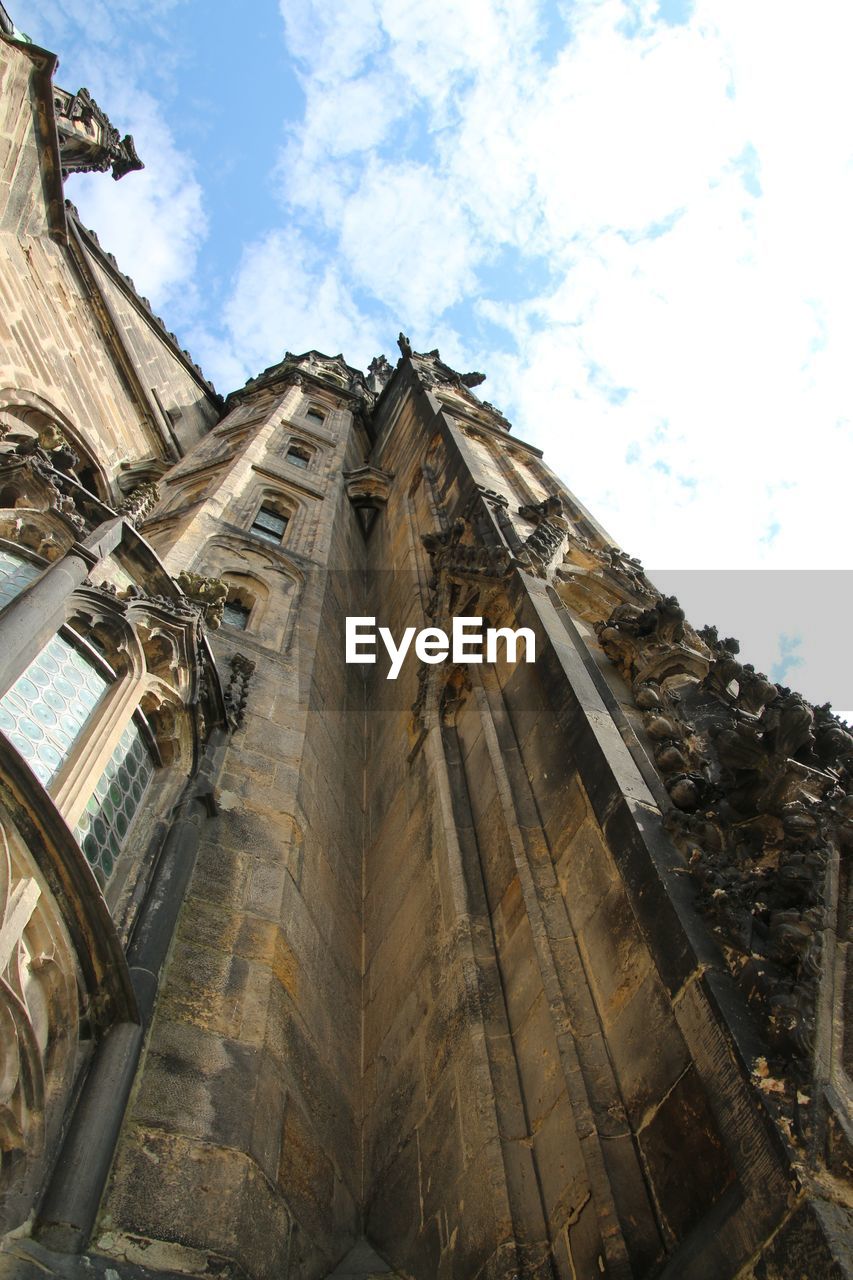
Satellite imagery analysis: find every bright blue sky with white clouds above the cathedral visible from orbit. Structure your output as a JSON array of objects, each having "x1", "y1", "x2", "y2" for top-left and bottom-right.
[{"x1": 6, "y1": 0, "x2": 853, "y2": 718}]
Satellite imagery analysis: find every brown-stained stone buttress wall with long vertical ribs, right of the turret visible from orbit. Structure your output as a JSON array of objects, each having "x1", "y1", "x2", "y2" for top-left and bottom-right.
[{"x1": 350, "y1": 360, "x2": 809, "y2": 1277}]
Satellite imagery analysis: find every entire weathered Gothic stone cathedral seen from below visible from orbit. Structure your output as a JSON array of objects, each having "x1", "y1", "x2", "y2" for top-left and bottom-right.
[{"x1": 0, "y1": 8, "x2": 853, "y2": 1280}]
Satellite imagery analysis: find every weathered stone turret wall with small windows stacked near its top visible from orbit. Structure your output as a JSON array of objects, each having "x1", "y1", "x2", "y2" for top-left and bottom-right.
[{"x1": 96, "y1": 366, "x2": 365, "y2": 1277}]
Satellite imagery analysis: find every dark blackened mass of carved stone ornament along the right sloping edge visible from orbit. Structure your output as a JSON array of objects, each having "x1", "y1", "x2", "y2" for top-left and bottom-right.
[{"x1": 578, "y1": 557, "x2": 853, "y2": 1142}]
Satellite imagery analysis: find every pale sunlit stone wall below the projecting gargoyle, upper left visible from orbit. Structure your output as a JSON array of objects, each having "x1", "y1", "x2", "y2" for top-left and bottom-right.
[{"x1": 0, "y1": 38, "x2": 219, "y2": 500}]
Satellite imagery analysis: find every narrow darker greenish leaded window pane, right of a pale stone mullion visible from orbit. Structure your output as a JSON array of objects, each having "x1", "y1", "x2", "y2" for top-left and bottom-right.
[{"x1": 74, "y1": 721, "x2": 154, "y2": 887}]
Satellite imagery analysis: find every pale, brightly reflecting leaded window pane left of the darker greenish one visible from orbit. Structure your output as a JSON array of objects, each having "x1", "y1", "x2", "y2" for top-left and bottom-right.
[{"x1": 0, "y1": 636, "x2": 109, "y2": 786}]
